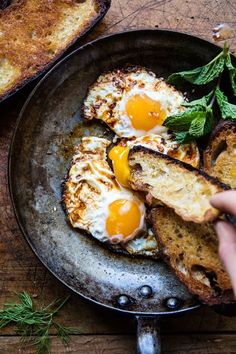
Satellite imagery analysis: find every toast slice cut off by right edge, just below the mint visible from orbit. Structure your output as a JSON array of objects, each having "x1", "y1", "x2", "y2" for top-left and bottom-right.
[{"x1": 203, "y1": 121, "x2": 236, "y2": 188}]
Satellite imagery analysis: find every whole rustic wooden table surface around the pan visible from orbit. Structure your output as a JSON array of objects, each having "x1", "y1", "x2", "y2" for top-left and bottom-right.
[{"x1": 0, "y1": 0, "x2": 236, "y2": 354}]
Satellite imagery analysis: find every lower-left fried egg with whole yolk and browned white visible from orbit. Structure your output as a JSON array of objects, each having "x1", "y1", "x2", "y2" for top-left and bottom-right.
[{"x1": 63, "y1": 137, "x2": 146, "y2": 244}]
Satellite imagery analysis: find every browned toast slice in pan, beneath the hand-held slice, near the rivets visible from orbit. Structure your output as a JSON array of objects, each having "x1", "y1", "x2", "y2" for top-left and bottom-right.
[{"x1": 151, "y1": 207, "x2": 234, "y2": 305}]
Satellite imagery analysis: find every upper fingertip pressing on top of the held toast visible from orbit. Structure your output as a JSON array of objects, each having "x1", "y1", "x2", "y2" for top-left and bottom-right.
[{"x1": 210, "y1": 191, "x2": 236, "y2": 215}]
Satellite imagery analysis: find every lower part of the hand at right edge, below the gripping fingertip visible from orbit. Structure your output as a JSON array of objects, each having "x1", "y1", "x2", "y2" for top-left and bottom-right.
[{"x1": 215, "y1": 221, "x2": 236, "y2": 295}]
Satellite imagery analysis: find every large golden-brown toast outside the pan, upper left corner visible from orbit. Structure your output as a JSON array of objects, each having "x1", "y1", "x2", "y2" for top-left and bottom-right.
[{"x1": 0, "y1": 0, "x2": 109, "y2": 100}]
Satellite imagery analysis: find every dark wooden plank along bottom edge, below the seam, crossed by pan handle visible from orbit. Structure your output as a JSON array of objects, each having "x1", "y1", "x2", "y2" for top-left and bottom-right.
[{"x1": 0, "y1": 334, "x2": 236, "y2": 354}]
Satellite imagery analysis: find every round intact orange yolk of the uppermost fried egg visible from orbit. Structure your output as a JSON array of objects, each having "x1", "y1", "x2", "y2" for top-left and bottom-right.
[{"x1": 126, "y1": 94, "x2": 166, "y2": 131}]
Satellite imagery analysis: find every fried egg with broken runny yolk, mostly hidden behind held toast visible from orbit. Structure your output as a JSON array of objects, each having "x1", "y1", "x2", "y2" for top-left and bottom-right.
[{"x1": 108, "y1": 134, "x2": 200, "y2": 188}]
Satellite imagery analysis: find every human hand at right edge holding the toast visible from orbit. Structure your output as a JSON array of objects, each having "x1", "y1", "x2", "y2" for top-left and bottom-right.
[{"x1": 210, "y1": 191, "x2": 236, "y2": 296}]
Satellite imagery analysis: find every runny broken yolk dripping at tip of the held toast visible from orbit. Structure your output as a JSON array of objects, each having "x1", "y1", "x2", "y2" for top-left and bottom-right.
[{"x1": 108, "y1": 145, "x2": 130, "y2": 187}]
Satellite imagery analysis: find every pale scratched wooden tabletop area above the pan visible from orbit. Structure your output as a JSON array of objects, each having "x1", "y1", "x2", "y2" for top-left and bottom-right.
[{"x1": 90, "y1": 0, "x2": 236, "y2": 51}]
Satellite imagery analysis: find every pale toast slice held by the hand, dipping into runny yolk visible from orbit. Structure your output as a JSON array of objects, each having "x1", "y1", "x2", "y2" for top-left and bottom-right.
[{"x1": 129, "y1": 146, "x2": 230, "y2": 223}]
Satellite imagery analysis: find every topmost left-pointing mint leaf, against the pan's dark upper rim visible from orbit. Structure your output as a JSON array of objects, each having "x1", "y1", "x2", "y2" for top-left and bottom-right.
[{"x1": 167, "y1": 51, "x2": 225, "y2": 85}]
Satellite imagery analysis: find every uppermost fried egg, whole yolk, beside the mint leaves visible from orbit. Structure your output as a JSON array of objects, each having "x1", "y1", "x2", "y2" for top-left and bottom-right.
[{"x1": 83, "y1": 67, "x2": 185, "y2": 138}]
